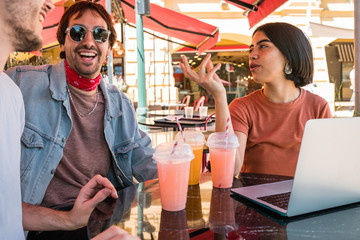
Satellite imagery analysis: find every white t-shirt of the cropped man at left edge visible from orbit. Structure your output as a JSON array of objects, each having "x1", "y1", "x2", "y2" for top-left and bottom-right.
[{"x1": 0, "y1": 73, "x2": 24, "y2": 239}]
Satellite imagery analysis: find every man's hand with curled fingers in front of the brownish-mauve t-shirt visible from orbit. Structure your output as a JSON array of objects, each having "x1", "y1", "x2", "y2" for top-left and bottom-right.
[{"x1": 68, "y1": 175, "x2": 118, "y2": 229}]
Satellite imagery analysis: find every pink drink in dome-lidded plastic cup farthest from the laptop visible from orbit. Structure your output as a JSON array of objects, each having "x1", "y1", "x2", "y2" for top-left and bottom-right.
[{"x1": 153, "y1": 143, "x2": 194, "y2": 211}]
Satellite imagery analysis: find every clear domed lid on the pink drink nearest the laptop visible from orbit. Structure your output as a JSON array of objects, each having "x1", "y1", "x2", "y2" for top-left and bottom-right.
[{"x1": 206, "y1": 132, "x2": 240, "y2": 148}]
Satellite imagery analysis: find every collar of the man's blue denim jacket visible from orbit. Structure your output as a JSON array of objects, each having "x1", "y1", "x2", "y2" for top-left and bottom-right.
[{"x1": 50, "y1": 60, "x2": 122, "y2": 119}]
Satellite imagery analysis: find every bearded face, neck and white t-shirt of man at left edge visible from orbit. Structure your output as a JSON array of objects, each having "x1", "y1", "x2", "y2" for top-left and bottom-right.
[{"x1": 0, "y1": 0, "x2": 53, "y2": 239}]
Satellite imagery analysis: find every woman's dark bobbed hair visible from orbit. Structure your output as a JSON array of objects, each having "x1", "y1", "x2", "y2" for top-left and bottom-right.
[{"x1": 253, "y1": 22, "x2": 314, "y2": 87}]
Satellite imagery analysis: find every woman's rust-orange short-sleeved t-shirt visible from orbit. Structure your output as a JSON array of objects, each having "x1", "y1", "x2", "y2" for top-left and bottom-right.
[{"x1": 229, "y1": 89, "x2": 332, "y2": 176}]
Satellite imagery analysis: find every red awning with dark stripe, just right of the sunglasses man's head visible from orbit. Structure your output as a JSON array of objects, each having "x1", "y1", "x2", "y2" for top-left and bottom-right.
[{"x1": 121, "y1": 0, "x2": 219, "y2": 53}]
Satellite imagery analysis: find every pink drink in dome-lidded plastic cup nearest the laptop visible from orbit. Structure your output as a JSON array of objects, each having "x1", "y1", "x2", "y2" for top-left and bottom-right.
[{"x1": 206, "y1": 132, "x2": 240, "y2": 188}]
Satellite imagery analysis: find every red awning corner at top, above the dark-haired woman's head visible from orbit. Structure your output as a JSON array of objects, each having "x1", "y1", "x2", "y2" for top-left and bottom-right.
[{"x1": 225, "y1": 0, "x2": 287, "y2": 28}]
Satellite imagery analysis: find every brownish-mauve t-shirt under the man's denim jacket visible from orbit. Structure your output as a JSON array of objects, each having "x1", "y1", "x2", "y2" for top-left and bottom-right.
[{"x1": 41, "y1": 87, "x2": 111, "y2": 209}]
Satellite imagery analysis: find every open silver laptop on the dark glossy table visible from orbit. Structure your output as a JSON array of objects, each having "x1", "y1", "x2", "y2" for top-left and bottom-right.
[{"x1": 231, "y1": 117, "x2": 360, "y2": 217}]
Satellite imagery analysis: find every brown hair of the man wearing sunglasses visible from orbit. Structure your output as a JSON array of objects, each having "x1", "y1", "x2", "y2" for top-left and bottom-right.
[{"x1": 56, "y1": 1, "x2": 116, "y2": 58}]
